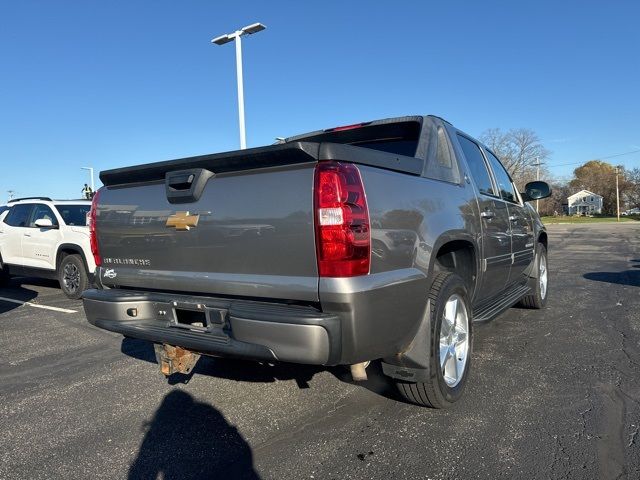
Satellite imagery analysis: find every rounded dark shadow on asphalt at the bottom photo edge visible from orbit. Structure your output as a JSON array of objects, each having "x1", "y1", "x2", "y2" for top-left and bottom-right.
[{"x1": 128, "y1": 390, "x2": 260, "y2": 480}]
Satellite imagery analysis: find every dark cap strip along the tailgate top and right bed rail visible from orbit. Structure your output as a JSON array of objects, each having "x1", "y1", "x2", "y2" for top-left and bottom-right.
[{"x1": 100, "y1": 142, "x2": 424, "y2": 187}]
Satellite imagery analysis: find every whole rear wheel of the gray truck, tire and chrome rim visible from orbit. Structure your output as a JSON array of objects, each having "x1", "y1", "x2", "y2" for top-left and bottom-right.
[{"x1": 397, "y1": 272, "x2": 473, "y2": 408}]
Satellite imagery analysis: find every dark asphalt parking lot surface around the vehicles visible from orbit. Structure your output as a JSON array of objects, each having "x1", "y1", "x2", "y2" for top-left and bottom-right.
[{"x1": 0, "y1": 224, "x2": 640, "y2": 479}]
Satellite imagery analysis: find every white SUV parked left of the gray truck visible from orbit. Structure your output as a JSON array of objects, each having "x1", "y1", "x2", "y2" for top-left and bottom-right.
[{"x1": 0, "y1": 197, "x2": 96, "y2": 299}]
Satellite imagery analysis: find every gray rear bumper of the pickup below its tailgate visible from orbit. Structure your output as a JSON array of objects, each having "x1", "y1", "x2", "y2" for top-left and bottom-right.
[{"x1": 83, "y1": 289, "x2": 341, "y2": 365}]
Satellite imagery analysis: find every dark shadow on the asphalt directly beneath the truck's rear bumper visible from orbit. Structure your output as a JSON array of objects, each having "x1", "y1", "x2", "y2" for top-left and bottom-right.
[{"x1": 120, "y1": 337, "x2": 405, "y2": 403}]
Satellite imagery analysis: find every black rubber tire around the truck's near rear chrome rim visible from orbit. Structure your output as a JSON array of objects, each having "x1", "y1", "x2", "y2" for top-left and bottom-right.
[{"x1": 396, "y1": 272, "x2": 473, "y2": 408}]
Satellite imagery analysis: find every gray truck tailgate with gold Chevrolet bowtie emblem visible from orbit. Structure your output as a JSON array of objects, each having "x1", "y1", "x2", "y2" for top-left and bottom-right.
[{"x1": 96, "y1": 145, "x2": 318, "y2": 302}]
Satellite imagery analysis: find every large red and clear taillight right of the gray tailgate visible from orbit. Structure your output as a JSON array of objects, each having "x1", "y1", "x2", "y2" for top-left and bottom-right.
[{"x1": 314, "y1": 162, "x2": 371, "y2": 277}]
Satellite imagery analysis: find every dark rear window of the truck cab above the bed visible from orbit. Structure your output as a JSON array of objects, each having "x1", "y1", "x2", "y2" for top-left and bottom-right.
[{"x1": 289, "y1": 121, "x2": 420, "y2": 157}]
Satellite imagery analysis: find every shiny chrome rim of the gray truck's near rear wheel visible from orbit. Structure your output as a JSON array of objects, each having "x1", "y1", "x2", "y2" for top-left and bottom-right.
[{"x1": 440, "y1": 293, "x2": 469, "y2": 388}]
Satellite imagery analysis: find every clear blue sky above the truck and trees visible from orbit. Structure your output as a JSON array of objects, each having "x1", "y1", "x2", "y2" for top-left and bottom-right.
[{"x1": 0, "y1": 0, "x2": 640, "y2": 202}]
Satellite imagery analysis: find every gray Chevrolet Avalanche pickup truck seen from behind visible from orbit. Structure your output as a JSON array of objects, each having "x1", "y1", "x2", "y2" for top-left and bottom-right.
[{"x1": 83, "y1": 116, "x2": 550, "y2": 408}]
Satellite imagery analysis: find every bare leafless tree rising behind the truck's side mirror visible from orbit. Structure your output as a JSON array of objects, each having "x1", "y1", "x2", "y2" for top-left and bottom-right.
[{"x1": 480, "y1": 128, "x2": 551, "y2": 185}]
